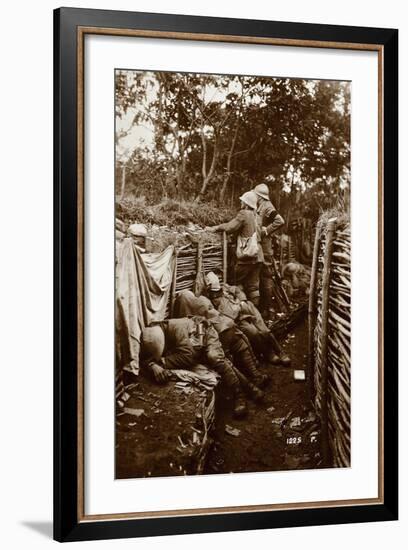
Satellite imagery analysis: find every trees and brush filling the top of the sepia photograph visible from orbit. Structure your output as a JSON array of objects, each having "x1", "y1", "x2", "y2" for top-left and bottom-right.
[{"x1": 116, "y1": 71, "x2": 350, "y2": 221}]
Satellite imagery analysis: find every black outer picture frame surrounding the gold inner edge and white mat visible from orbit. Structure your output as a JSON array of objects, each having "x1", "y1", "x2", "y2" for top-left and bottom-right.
[{"x1": 54, "y1": 8, "x2": 398, "y2": 541}]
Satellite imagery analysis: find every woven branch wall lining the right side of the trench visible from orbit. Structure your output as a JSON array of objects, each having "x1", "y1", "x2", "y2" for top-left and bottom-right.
[{"x1": 312, "y1": 223, "x2": 351, "y2": 467}]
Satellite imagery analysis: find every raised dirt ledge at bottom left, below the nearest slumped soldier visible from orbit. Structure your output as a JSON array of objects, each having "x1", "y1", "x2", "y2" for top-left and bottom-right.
[{"x1": 115, "y1": 376, "x2": 214, "y2": 479}]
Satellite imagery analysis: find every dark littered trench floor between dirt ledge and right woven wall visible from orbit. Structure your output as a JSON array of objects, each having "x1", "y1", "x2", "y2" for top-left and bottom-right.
[{"x1": 204, "y1": 321, "x2": 321, "y2": 474}]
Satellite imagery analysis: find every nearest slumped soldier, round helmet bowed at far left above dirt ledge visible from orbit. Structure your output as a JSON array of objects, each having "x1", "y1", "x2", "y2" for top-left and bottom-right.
[{"x1": 141, "y1": 316, "x2": 247, "y2": 418}]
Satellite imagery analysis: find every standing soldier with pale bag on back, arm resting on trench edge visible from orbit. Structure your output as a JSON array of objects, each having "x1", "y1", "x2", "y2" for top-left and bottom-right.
[{"x1": 206, "y1": 191, "x2": 263, "y2": 306}]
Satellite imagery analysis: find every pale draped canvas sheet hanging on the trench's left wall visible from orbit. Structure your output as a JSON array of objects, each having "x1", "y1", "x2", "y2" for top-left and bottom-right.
[{"x1": 116, "y1": 238, "x2": 175, "y2": 374}]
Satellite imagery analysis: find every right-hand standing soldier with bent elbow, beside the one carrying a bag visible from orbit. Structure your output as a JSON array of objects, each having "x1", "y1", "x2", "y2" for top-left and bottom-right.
[{"x1": 254, "y1": 183, "x2": 284, "y2": 318}]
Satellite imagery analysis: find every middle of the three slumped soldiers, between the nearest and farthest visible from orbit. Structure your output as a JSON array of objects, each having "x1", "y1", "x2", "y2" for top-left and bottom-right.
[{"x1": 174, "y1": 290, "x2": 269, "y2": 392}]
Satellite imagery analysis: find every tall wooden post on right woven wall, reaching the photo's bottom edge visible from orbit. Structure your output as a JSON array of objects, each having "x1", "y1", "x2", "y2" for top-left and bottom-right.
[{"x1": 321, "y1": 218, "x2": 336, "y2": 466}]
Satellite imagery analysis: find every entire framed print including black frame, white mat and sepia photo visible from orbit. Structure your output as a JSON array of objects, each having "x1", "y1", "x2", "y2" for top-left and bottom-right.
[{"x1": 54, "y1": 8, "x2": 398, "y2": 541}]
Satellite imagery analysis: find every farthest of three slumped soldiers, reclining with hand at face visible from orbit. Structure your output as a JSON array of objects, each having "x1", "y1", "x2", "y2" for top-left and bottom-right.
[{"x1": 207, "y1": 271, "x2": 290, "y2": 366}]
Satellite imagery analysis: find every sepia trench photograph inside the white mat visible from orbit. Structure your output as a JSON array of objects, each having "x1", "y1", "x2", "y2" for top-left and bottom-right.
[{"x1": 112, "y1": 68, "x2": 352, "y2": 479}]
